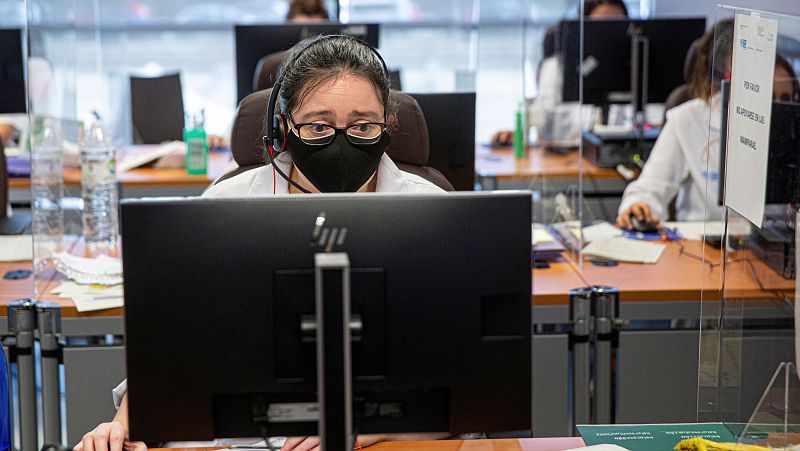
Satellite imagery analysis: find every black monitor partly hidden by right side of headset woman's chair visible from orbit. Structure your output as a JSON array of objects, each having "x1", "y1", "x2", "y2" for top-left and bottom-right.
[{"x1": 409, "y1": 92, "x2": 475, "y2": 191}]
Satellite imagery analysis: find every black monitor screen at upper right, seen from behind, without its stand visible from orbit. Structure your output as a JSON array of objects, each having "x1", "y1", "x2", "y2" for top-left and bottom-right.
[{"x1": 559, "y1": 18, "x2": 706, "y2": 105}]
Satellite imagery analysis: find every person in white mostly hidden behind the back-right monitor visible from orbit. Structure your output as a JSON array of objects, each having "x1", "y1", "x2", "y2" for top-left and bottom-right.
[{"x1": 491, "y1": 0, "x2": 628, "y2": 146}]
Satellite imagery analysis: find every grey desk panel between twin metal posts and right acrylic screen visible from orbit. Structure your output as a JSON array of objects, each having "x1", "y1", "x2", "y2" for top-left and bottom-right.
[{"x1": 616, "y1": 330, "x2": 700, "y2": 423}]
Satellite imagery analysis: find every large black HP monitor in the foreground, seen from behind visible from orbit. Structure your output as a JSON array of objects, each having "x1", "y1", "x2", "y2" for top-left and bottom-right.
[{"x1": 121, "y1": 191, "x2": 532, "y2": 442}]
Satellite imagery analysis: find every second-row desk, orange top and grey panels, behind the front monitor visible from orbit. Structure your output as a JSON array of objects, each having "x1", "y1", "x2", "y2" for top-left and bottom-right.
[{"x1": 0, "y1": 242, "x2": 794, "y2": 449}]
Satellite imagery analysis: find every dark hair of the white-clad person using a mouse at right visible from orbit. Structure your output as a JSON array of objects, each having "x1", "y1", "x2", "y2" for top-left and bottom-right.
[{"x1": 688, "y1": 19, "x2": 733, "y2": 100}]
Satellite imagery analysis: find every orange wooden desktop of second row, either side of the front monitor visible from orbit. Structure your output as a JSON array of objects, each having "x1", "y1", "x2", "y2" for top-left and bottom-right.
[{"x1": 0, "y1": 241, "x2": 795, "y2": 318}]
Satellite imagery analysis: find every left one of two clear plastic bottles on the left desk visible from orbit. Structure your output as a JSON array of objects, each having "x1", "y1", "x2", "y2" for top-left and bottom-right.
[{"x1": 31, "y1": 118, "x2": 64, "y2": 270}]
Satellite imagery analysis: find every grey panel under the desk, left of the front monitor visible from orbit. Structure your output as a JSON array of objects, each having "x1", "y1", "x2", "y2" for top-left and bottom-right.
[{"x1": 64, "y1": 346, "x2": 125, "y2": 445}]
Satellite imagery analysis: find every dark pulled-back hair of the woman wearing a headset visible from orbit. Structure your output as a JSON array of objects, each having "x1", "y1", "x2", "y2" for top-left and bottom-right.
[{"x1": 278, "y1": 36, "x2": 393, "y2": 117}]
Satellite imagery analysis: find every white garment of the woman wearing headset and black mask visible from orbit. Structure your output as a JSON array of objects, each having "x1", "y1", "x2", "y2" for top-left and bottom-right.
[{"x1": 112, "y1": 153, "x2": 445, "y2": 448}]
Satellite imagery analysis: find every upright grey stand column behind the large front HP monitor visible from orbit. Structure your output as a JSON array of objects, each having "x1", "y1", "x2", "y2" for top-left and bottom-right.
[{"x1": 314, "y1": 252, "x2": 353, "y2": 451}]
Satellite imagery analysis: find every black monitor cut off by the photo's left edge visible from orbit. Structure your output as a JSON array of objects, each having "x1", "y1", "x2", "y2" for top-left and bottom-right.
[{"x1": 0, "y1": 28, "x2": 27, "y2": 113}]
